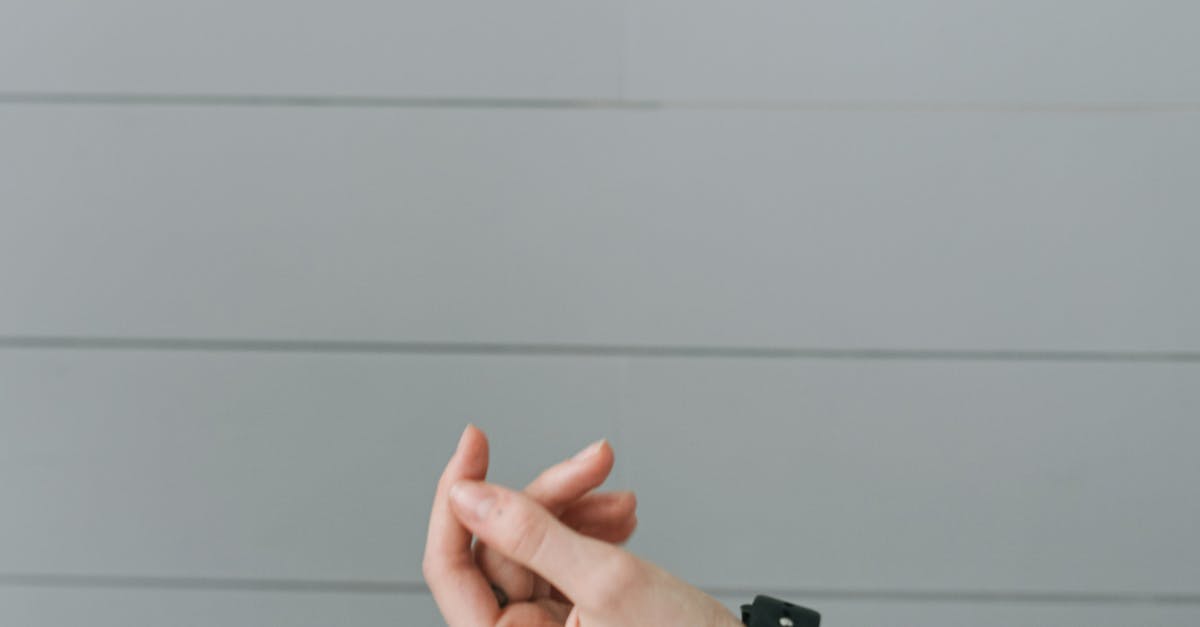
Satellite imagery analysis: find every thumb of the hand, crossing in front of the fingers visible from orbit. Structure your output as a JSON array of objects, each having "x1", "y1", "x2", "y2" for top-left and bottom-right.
[{"x1": 450, "y1": 480, "x2": 643, "y2": 609}]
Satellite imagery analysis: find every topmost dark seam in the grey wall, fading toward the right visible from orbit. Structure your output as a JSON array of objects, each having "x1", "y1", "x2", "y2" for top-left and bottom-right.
[{"x1": 0, "y1": 91, "x2": 1200, "y2": 113}]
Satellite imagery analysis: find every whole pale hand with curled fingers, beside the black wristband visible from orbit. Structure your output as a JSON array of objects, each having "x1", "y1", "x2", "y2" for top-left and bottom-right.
[{"x1": 424, "y1": 426, "x2": 742, "y2": 627}]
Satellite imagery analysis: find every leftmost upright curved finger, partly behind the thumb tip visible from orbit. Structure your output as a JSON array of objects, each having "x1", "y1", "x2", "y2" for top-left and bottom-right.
[{"x1": 422, "y1": 425, "x2": 500, "y2": 627}]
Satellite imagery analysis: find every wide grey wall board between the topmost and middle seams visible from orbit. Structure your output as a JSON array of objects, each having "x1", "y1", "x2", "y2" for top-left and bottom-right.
[{"x1": 0, "y1": 106, "x2": 1200, "y2": 351}]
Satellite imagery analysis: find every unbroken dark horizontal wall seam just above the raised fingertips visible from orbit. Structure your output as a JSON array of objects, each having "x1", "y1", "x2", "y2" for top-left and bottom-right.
[{"x1": 0, "y1": 335, "x2": 1200, "y2": 363}]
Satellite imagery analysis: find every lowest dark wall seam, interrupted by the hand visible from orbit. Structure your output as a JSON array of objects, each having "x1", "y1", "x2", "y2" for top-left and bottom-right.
[{"x1": 0, "y1": 573, "x2": 1200, "y2": 605}]
